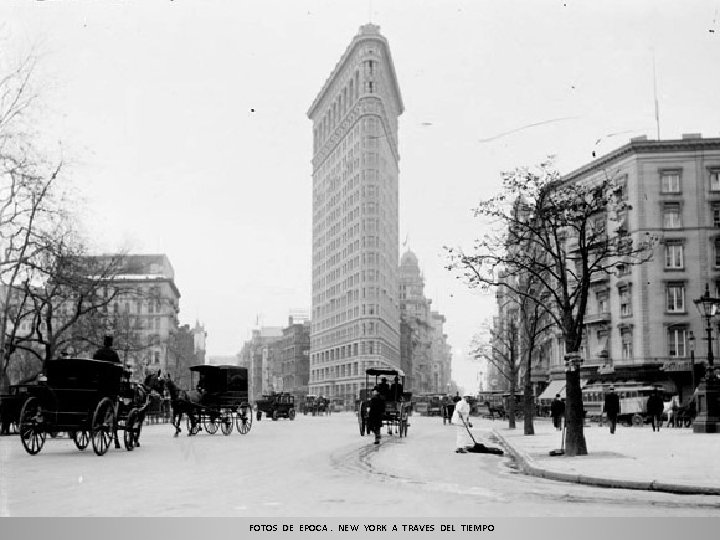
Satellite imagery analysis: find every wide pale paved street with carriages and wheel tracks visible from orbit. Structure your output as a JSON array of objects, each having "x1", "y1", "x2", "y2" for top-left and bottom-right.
[{"x1": 0, "y1": 413, "x2": 720, "y2": 517}]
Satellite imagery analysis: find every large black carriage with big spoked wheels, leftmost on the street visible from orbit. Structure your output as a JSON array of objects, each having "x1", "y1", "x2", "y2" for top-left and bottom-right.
[{"x1": 19, "y1": 358, "x2": 141, "y2": 456}]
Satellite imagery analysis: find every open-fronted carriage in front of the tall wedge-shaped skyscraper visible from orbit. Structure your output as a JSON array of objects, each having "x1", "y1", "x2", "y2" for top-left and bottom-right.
[{"x1": 357, "y1": 368, "x2": 412, "y2": 437}]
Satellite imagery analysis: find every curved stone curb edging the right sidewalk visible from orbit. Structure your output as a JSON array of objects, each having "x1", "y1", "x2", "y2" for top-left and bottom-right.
[{"x1": 492, "y1": 428, "x2": 720, "y2": 495}]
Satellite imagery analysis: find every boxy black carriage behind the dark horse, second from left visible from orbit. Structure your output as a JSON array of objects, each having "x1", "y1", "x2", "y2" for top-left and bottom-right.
[{"x1": 187, "y1": 364, "x2": 252, "y2": 435}]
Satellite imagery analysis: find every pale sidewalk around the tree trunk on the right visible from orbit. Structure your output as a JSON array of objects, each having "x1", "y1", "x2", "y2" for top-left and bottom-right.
[{"x1": 490, "y1": 419, "x2": 720, "y2": 495}]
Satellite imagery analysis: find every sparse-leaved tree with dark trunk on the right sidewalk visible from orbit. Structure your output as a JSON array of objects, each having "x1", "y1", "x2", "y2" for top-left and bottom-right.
[{"x1": 446, "y1": 160, "x2": 654, "y2": 456}]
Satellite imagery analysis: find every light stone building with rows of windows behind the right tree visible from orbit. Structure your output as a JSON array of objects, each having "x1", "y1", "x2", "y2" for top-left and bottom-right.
[{"x1": 499, "y1": 134, "x2": 720, "y2": 401}]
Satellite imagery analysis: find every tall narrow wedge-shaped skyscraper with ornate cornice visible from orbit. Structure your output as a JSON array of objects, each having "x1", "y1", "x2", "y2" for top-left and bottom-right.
[{"x1": 307, "y1": 24, "x2": 403, "y2": 405}]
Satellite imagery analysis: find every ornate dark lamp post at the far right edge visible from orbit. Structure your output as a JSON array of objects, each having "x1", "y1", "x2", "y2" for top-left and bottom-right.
[{"x1": 691, "y1": 283, "x2": 720, "y2": 433}]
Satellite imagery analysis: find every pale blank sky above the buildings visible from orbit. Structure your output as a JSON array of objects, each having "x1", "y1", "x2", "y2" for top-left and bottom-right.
[{"x1": 0, "y1": 0, "x2": 720, "y2": 387}]
